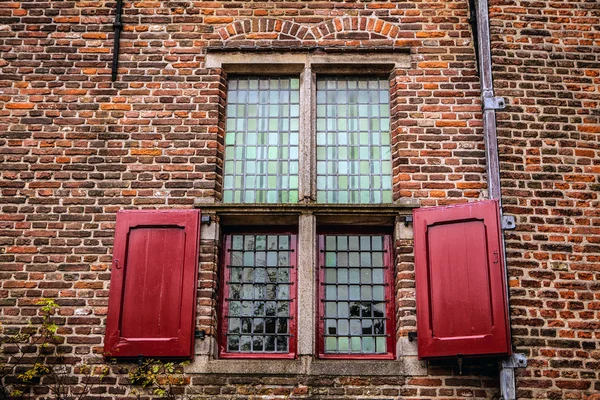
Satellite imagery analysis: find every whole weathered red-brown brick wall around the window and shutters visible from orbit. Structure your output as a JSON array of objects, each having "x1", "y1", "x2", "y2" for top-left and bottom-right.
[{"x1": 0, "y1": 0, "x2": 600, "y2": 399}]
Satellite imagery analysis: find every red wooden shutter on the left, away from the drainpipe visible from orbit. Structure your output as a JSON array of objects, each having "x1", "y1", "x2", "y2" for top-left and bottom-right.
[{"x1": 104, "y1": 210, "x2": 200, "y2": 357}]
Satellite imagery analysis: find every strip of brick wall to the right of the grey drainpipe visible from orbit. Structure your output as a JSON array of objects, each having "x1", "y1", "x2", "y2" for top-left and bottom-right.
[{"x1": 490, "y1": 0, "x2": 600, "y2": 399}]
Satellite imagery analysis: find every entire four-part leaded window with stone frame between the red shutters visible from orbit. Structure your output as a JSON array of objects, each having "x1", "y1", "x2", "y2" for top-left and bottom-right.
[{"x1": 205, "y1": 53, "x2": 409, "y2": 359}]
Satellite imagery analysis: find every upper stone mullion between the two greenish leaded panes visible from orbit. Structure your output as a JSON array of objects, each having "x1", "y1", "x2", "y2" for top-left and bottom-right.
[{"x1": 298, "y1": 65, "x2": 316, "y2": 202}]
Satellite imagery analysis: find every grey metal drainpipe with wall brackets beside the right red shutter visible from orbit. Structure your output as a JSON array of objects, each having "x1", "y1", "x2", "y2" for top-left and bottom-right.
[{"x1": 476, "y1": 0, "x2": 527, "y2": 400}]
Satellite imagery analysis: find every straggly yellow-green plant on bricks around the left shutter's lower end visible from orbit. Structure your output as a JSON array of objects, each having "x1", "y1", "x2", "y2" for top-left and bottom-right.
[{"x1": 0, "y1": 299, "x2": 193, "y2": 400}]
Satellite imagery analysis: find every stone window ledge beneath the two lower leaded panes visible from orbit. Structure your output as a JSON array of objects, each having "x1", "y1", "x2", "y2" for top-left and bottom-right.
[{"x1": 186, "y1": 356, "x2": 427, "y2": 376}]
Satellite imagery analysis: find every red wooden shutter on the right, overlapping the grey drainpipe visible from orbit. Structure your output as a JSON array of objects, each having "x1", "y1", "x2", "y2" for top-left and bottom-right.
[{"x1": 413, "y1": 200, "x2": 510, "y2": 358}]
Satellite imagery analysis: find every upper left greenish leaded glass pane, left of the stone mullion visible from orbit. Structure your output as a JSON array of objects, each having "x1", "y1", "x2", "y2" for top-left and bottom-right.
[{"x1": 223, "y1": 77, "x2": 300, "y2": 203}]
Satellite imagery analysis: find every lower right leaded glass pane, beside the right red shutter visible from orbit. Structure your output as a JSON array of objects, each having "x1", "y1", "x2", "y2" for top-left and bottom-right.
[{"x1": 319, "y1": 235, "x2": 393, "y2": 356}]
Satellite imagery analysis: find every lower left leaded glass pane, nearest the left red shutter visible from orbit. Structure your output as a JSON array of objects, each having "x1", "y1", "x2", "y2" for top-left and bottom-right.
[{"x1": 223, "y1": 234, "x2": 296, "y2": 356}]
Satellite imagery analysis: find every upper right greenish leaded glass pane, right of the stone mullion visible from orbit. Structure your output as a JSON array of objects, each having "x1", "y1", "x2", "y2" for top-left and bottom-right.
[{"x1": 316, "y1": 76, "x2": 392, "y2": 204}]
